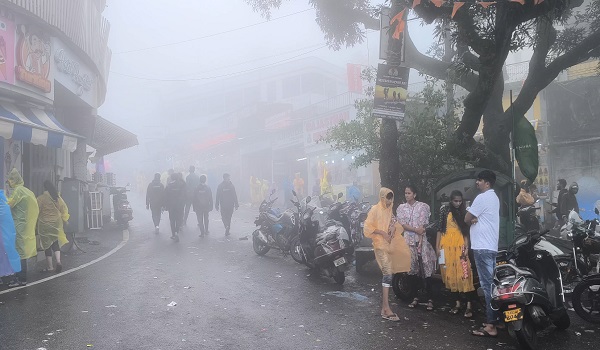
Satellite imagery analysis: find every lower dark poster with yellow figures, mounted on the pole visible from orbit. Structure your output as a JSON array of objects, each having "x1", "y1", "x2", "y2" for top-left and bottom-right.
[{"x1": 373, "y1": 64, "x2": 410, "y2": 121}]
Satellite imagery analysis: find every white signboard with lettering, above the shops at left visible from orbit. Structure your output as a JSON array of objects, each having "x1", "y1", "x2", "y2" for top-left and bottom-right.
[{"x1": 52, "y1": 38, "x2": 98, "y2": 108}]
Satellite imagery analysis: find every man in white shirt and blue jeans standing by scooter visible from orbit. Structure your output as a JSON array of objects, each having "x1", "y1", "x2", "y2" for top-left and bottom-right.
[{"x1": 465, "y1": 170, "x2": 500, "y2": 337}]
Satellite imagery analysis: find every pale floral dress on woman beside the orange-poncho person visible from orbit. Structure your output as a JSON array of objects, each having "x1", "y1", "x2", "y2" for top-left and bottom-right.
[{"x1": 396, "y1": 201, "x2": 437, "y2": 278}]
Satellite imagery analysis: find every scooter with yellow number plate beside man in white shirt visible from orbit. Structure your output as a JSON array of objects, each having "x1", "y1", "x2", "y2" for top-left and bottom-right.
[{"x1": 491, "y1": 231, "x2": 571, "y2": 349}]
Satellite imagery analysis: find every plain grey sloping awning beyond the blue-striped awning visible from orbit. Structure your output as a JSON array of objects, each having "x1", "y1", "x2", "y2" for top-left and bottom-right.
[{"x1": 88, "y1": 115, "x2": 139, "y2": 156}]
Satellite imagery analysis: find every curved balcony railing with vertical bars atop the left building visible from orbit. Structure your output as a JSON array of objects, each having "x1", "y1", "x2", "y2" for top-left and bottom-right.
[{"x1": 7, "y1": 0, "x2": 111, "y2": 90}]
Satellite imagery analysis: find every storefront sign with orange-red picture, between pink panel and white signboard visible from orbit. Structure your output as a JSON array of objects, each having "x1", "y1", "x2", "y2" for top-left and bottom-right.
[{"x1": 15, "y1": 25, "x2": 52, "y2": 93}]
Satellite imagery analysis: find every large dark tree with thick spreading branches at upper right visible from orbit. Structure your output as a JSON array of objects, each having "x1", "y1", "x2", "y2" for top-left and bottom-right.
[{"x1": 246, "y1": 0, "x2": 600, "y2": 174}]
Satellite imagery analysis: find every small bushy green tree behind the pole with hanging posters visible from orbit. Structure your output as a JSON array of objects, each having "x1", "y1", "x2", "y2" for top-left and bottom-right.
[{"x1": 322, "y1": 69, "x2": 464, "y2": 205}]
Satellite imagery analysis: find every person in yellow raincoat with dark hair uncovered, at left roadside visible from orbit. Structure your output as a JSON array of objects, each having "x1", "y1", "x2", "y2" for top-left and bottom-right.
[{"x1": 38, "y1": 180, "x2": 69, "y2": 273}]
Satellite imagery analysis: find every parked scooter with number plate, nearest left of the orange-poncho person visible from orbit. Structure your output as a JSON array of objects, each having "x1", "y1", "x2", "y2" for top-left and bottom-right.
[{"x1": 292, "y1": 193, "x2": 354, "y2": 284}]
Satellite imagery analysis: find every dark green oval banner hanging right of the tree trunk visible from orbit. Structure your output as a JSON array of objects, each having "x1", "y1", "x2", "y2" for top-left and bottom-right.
[{"x1": 514, "y1": 116, "x2": 540, "y2": 183}]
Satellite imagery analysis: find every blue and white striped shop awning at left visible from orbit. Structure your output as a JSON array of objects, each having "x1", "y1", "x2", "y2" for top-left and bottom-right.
[{"x1": 0, "y1": 103, "x2": 83, "y2": 152}]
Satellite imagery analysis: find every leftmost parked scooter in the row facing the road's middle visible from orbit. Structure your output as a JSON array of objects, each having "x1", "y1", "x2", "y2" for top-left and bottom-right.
[{"x1": 252, "y1": 190, "x2": 301, "y2": 262}]
